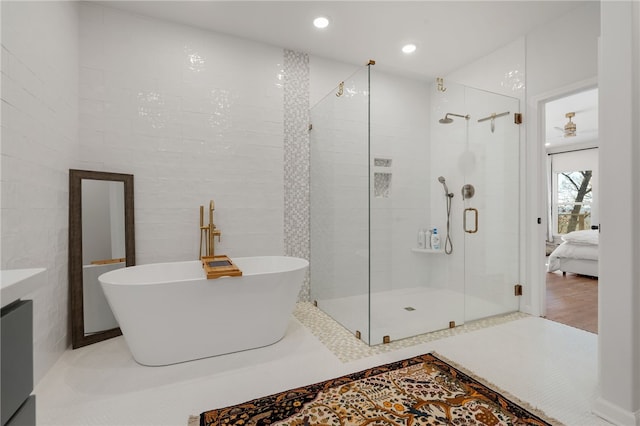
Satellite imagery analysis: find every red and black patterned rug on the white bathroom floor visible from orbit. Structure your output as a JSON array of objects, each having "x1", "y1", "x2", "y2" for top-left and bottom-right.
[{"x1": 189, "y1": 354, "x2": 560, "y2": 426}]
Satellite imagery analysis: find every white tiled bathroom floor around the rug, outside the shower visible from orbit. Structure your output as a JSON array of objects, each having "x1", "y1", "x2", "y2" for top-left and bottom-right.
[{"x1": 35, "y1": 304, "x2": 608, "y2": 426}]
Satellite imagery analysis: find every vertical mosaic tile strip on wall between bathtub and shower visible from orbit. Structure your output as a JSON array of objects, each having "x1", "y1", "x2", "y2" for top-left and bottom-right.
[{"x1": 284, "y1": 50, "x2": 310, "y2": 301}]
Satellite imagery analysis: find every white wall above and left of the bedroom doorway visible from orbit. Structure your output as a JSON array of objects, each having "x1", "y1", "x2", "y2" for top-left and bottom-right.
[{"x1": 521, "y1": 2, "x2": 600, "y2": 315}]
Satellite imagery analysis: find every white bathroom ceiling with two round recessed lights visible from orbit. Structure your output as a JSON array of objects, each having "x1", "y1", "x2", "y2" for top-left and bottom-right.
[{"x1": 92, "y1": 0, "x2": 586, "y2": 79}]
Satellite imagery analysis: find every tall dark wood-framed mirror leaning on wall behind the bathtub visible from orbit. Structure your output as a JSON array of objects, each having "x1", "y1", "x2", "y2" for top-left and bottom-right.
[{"x1": 69, "y1": 169, "x2": 135, "y2": 349}]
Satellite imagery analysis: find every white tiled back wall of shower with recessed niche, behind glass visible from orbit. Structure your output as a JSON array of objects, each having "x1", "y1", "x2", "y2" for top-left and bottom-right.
[{"x1": 311, "y1": 61, "x2": 430, "y2": 306}]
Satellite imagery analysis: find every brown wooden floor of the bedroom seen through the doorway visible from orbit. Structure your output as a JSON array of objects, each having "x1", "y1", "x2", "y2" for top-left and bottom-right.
[{"x1": 546, "y1": 272, "x2": 598, "y2": 334}]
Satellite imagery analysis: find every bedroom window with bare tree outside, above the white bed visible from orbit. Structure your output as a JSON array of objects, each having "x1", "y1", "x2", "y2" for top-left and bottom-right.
[{"x1": 555, "y1": 170, "x2": 593, "y2": 234}]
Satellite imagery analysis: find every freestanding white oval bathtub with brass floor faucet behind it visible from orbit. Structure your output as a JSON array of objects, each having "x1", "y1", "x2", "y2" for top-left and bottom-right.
[{"x1": 99, "y1": 256, "x2": 309, "y2": 366}]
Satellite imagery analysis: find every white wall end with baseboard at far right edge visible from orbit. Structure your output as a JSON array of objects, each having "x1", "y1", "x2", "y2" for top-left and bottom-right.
[{"x1": 594, "y1": 1, "x2": 640, "y2": 425}]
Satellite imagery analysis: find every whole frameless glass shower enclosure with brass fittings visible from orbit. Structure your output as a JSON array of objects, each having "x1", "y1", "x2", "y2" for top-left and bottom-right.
[{"x1": 310, "y1": 65, "x2": 520, "y2": 345}]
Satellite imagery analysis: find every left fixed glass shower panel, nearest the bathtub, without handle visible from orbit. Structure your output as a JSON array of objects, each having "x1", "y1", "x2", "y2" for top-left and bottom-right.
[{"x1": 310, "y1": 67, "x2": 369, "y2": 343}]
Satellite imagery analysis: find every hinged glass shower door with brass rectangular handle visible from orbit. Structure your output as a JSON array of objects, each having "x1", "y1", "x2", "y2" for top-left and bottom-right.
[{"x1": 460, "y1": 88, "x2": 520, "y2": 321}]
